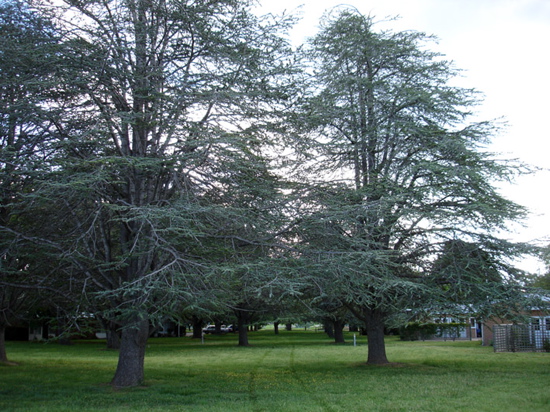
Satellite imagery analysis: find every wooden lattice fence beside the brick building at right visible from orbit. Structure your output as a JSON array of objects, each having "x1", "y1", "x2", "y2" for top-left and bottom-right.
[{"x1": 493, "y1": 322, "x2": 550, "y2": 352}]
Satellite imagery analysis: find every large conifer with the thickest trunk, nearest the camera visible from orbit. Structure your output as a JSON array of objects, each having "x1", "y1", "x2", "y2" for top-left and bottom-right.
[{"x1": 17, "y1": 0, "x2": 300, "y2": 387}]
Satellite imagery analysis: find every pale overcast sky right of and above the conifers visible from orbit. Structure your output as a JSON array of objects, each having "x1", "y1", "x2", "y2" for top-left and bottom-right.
[{"x1": 260, "y1": 0, "x2": 550, "y2": 272}]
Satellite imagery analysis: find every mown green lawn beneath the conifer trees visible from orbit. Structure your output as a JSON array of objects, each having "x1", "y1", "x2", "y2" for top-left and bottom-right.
[{"x1": 0, "y1": 331, "x2": 550, "y2": 412}]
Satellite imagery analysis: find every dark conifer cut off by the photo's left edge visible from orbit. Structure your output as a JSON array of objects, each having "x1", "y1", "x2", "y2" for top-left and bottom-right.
[{"x1": 0, "y1": 1, "x2": 64, "y2": 362}]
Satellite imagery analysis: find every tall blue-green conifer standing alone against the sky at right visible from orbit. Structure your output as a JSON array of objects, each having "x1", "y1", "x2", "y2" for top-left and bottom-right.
[{"x1": 298, "y1": 10, "x2": 524, "y2": 364}]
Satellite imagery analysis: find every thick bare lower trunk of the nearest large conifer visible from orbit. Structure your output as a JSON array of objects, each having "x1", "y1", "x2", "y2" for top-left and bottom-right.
[{"x1": 111, "y1": 320, "x2": 149, "y2": 388}]
